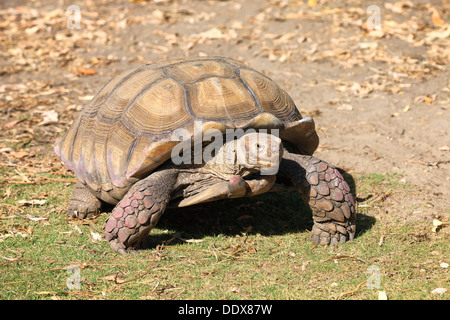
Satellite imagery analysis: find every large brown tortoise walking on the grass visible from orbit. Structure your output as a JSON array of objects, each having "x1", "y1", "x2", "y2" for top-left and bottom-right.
[{"x1": 55, "y1": 57, "x2": 356, "y2": 254}]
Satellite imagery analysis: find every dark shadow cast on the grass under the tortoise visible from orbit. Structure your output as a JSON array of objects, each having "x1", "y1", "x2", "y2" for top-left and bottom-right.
[{"x1": 145, "y1": 168, "x2": 376, "y2": 248}]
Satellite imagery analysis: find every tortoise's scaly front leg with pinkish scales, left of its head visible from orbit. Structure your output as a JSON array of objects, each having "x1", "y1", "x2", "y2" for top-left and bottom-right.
[{"x1": 105, "y1": 170, "x2": 177, "y2": 254}]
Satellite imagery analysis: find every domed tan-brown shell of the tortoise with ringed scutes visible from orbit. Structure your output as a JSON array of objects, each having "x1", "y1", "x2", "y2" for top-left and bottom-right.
[{"x1": 55, "y1": 57, "x2": 318, "y2": 204}]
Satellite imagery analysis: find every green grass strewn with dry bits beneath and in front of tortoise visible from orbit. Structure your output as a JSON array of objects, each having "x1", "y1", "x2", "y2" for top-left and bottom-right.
[{"x1": 0, "y1": 174, "x2": 450, "y2": 300}]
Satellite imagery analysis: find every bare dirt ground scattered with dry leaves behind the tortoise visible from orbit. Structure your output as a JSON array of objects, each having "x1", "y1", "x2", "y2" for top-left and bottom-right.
[{"x1": 0, "y1": 0, "x2": 450, "y2": 219}]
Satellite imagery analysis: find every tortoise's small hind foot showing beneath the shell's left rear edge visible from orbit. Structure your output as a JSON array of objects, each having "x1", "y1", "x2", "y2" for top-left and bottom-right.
[{"x1": 68, "y1": 181, "x2": 102, "y2": 219}]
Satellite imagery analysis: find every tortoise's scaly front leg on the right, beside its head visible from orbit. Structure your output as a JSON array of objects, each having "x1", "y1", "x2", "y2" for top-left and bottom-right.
[{"x1": 279, "y1": 152, "x2": 356, "y2": 245}]
